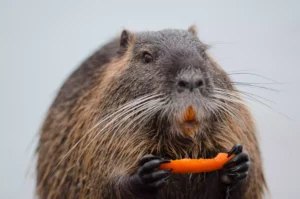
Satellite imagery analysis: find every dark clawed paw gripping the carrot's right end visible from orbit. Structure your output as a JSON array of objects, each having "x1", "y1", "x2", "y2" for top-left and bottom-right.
[{"x1": 221, "y1": 145, "x2": 250, "y2": 184}]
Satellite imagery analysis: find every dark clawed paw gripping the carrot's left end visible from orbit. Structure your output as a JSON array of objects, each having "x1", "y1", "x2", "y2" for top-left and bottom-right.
[{"x1": 130, "y1": 155, "x2": 171, "y2": 195}]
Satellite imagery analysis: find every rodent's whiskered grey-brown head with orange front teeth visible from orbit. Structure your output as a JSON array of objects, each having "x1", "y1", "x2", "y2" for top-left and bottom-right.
[{"x1": 104, "y1": 27, "x2": 239, "y2": 145}]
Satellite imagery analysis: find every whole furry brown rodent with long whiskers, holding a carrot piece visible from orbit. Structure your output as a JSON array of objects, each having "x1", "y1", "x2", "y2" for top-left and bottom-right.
[{"x1": 37, "y1": 26, "x2": 266, "y2": 199}]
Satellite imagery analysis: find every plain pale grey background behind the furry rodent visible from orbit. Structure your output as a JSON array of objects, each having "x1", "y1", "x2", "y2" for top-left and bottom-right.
[{"x1": 0, "y1": 0, "x2": 300, "y2": 199}]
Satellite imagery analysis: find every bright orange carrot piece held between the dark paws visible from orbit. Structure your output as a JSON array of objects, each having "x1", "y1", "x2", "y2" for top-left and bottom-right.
[{"x1": 159, "y1": 153, "x2": 234, "y2": 173}]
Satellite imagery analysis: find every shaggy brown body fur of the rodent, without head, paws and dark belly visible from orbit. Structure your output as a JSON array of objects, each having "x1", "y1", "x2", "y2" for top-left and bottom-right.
[{"x1": 37, "y1": 28, "x2": 265, "y2": 199}]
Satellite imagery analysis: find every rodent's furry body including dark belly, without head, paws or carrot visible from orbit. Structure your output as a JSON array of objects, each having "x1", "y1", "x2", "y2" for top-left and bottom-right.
[{"x1": 37, "y1": 28, "x2": 265, "y2": 199}]
